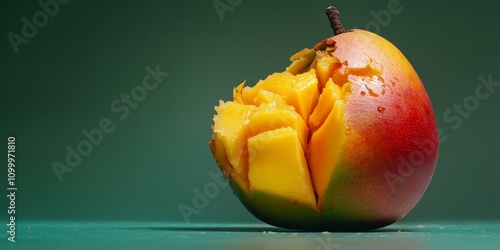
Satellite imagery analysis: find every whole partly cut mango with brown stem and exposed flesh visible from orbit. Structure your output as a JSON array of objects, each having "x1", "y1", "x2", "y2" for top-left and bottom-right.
[{"x1": 209, "y1": 8, "x2": 438, "y2": 230}]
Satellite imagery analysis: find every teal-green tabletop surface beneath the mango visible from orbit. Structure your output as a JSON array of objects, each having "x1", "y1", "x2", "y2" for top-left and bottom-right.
[{"x1": 1, "y1": 221, "x2": 500, "y2": 250}]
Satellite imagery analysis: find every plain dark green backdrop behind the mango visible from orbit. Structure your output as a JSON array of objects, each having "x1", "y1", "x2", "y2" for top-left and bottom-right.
[{"x1": 0, "y1": 0, "x2": 500, "y2": 227}]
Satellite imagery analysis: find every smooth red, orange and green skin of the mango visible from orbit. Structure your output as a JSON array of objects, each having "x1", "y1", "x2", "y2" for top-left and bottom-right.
[{"x1": 211, "y1": 30, "x2": 439, "y2": 231}]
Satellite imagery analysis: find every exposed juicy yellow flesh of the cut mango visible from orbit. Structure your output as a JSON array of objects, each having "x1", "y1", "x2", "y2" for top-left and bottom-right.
[{"x1": 210, "y1": 47, "x2": 349, "y2": 215}]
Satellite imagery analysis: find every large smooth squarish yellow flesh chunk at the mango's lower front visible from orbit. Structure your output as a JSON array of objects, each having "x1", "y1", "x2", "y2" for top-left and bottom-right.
[{"x1": 248, "y1": 127, "x2": 316, "y2": 207}]
